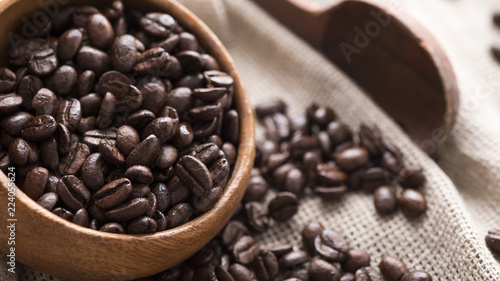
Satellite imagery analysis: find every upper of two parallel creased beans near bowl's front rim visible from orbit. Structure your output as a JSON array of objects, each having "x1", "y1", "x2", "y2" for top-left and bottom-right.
[{"x1": 94, "y1": 178, "x2": 132, "y2": 210}]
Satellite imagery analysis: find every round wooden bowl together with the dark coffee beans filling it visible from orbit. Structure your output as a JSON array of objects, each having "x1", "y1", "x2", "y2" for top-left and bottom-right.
[{"x1": 0, "y1": 0, "x2": 255, "y2": 280}]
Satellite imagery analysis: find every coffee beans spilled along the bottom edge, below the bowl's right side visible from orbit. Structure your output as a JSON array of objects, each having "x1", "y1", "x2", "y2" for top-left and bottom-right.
[{"x1": 141, "y1": 220, "x2": 432, "y2": 281}]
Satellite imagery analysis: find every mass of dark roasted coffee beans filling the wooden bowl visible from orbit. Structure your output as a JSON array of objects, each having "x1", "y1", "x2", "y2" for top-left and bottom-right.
[{"x1": 0, "y1": 0, "x2": 239, "y2": 234}]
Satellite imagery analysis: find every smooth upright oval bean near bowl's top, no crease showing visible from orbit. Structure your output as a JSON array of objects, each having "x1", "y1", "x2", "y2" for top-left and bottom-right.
[{"x1": 87, "y1": 13, "x2": 115, "y2": 50}]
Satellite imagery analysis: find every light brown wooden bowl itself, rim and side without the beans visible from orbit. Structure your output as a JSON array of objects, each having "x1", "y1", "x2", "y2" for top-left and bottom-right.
[{"x1": 0, "y1": 0, "x2": 255, "y2": 280}]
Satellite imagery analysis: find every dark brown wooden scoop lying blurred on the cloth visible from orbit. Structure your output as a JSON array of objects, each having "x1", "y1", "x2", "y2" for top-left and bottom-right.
[{"x1": 254, "y1": 0, "x2": 459, "y2": 153}]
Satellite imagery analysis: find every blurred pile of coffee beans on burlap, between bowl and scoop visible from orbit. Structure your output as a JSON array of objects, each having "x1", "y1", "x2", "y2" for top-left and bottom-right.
[{"x1": 252, "y1": 100, "x2": 427, "y2": 221}]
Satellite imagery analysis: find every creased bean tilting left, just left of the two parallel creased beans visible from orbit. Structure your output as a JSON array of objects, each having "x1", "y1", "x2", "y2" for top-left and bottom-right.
[{"x1": 57, "y1": 175, "x2": 91, "y2": 211}]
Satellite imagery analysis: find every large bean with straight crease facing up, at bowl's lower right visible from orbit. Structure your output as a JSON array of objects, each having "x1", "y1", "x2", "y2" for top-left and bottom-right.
[{"x1": 175, "y1": 155, "x2": 213, "y2": 195}]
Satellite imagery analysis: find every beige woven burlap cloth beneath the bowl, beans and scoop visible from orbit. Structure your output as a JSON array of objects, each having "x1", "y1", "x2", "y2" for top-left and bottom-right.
[{"x1": 0, "y1": 0, "x2": 500, "y2": 280}]
